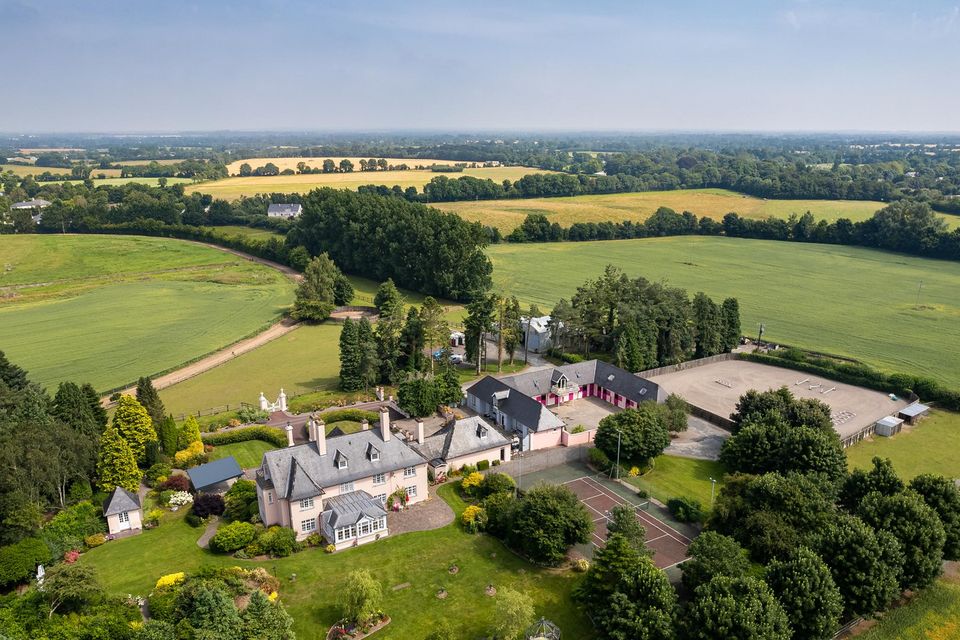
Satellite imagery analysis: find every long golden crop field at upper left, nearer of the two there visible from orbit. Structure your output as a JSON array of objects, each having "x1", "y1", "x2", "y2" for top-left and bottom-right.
[{"x1": 187, "y1": 167, "x2": 549, "y2": 200}]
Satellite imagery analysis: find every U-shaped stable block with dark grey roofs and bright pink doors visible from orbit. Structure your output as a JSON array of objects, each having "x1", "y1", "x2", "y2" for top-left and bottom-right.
[{"x1": 466, "y1": 360, "x2": 666, "y2": 451}]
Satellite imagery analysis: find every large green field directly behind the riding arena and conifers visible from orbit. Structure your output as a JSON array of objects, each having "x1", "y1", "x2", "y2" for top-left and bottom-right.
[{"x1": 488, "y1": 236, "x2": 960, "y2": 386}]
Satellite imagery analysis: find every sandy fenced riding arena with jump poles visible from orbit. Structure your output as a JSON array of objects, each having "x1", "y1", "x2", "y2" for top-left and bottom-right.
[{"x1": 650, "y1": 360, "x2": 907, "y2": 445}]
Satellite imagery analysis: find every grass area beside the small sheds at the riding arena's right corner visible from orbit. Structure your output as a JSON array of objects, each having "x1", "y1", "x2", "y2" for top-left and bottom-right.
[{"x1": 846, "y1": 411, "x2": 960, "y2": 479}]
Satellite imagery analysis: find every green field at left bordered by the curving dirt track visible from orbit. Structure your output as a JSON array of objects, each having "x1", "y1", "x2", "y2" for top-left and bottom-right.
[{"x1": 0, "y1": 235, "x2": 294, "y2": 391}]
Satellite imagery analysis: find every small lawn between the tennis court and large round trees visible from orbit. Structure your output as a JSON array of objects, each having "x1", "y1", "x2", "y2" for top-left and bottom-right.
[{"x1": 622, "y1": 455, "x2": 726, "y2": 509}]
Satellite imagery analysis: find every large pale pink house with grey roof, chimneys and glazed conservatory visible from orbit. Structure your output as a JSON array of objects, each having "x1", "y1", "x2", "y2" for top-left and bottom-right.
[{"x1": 256, "y1": 408, "x2": 427, "y2": 549}]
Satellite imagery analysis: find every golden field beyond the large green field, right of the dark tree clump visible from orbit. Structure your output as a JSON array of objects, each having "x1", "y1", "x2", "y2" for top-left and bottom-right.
[{"x1": 432, "y1": 189, "x2": 900, "y2": 233}]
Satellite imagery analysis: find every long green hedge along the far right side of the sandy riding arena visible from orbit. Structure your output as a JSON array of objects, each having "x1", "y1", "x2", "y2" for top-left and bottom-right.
[{"x1": 739, "y1": 349, "x2": 960, "y2": 411}]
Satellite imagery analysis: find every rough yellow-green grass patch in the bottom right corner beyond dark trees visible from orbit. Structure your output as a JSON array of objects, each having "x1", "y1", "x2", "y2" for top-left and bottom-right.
[{"x1": 857, "y1": 576, "x2": 960, "y2": 640}]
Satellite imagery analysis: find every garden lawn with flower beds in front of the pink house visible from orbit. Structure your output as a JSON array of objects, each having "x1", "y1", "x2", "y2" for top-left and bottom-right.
[{"x1": 81, "y1": 486, "x2": 593, "y2": 640}]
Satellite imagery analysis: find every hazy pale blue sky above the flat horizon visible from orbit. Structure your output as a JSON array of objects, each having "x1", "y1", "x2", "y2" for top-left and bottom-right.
[{"x1": 0, "y1": 0, "x2": 960, "y2": 133}]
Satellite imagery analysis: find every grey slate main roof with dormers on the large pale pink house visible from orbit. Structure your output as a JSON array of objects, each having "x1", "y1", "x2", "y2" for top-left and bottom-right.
[{"x1": 257, "y1": 429, "x2": 425, "y2": 500}]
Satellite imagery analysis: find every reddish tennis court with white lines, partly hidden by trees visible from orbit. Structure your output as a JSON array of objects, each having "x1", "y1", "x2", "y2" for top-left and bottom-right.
[{"x1": 563, "y1": 476, "x2": 690, "y2": 569}]
